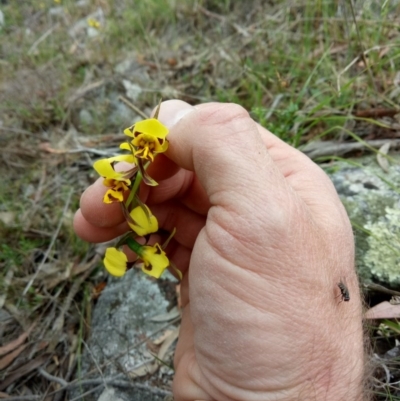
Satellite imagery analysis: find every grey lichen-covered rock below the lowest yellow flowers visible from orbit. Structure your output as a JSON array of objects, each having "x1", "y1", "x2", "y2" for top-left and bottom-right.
[{"x1": 71, "y1": 269, "x2": 175, "y2": 401}]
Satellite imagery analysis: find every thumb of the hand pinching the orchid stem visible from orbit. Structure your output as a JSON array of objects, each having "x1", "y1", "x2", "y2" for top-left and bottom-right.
[{"x1": 155, "y1": 100, "x2": 292, "y2": 234}]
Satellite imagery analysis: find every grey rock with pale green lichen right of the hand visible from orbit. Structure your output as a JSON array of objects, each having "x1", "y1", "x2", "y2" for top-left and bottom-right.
[{"x1": 327, "y1": 156, "x2": 400, "y2": 287}]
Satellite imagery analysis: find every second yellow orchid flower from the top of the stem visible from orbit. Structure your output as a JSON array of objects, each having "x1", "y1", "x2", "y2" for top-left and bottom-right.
[{"x1": 93, "y1": 155, "x2": 134, "y2": 203}]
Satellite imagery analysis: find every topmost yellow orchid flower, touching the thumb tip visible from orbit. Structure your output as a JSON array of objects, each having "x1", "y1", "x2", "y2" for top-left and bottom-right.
[{"x1": 124, "y1": 118, "x2": 169, "y2": 161}]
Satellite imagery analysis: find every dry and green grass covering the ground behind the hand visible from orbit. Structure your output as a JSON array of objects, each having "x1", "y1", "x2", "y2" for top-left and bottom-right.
[{"x1": 0, "y1": 0, "x2": 400, "y2": 400}]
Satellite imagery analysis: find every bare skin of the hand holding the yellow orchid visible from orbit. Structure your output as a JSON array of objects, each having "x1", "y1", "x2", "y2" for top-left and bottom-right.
[{"x1": 74, "y1": 100, "x2": 365, "y2": 401}]
